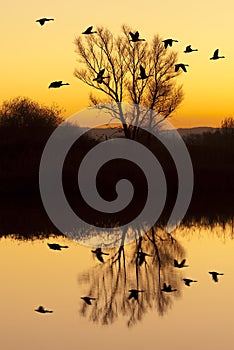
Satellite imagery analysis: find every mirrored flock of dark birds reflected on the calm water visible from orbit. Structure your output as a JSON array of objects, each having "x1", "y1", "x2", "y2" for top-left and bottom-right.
[{"x1": 34, "y1": 243, "x2": 223, "y2": 314}]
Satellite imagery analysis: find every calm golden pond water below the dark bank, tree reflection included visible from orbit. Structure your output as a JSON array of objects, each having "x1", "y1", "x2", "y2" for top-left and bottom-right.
[{"x1": 0, "y1": 222, "x2": 234, "y2": 350}]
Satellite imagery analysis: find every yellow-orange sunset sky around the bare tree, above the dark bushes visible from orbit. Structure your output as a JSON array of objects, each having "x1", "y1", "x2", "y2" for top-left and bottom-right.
[{"x1": 0, "y1": 0, "x2": 234, "y2": 127}]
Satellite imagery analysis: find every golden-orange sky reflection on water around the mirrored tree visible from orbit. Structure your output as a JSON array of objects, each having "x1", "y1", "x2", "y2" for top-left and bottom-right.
[{"x1": 0, "y1": 227, "x2": 234, "y2": 350}]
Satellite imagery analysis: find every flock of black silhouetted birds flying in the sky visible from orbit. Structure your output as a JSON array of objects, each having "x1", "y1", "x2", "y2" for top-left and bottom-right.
[{"x1": 36, "y1": 17, "x2": 225, "y2": 88}]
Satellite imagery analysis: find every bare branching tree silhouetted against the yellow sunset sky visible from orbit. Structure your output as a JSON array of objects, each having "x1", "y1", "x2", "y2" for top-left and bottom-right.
[{"x1": 74, "y1": 26, "x2": 183, "y2": 139}]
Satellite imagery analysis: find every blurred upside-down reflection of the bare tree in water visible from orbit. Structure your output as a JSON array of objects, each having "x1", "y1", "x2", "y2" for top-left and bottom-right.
[{"x1": 80, "y1": 228, "x2": 184, "y2": 326}]
